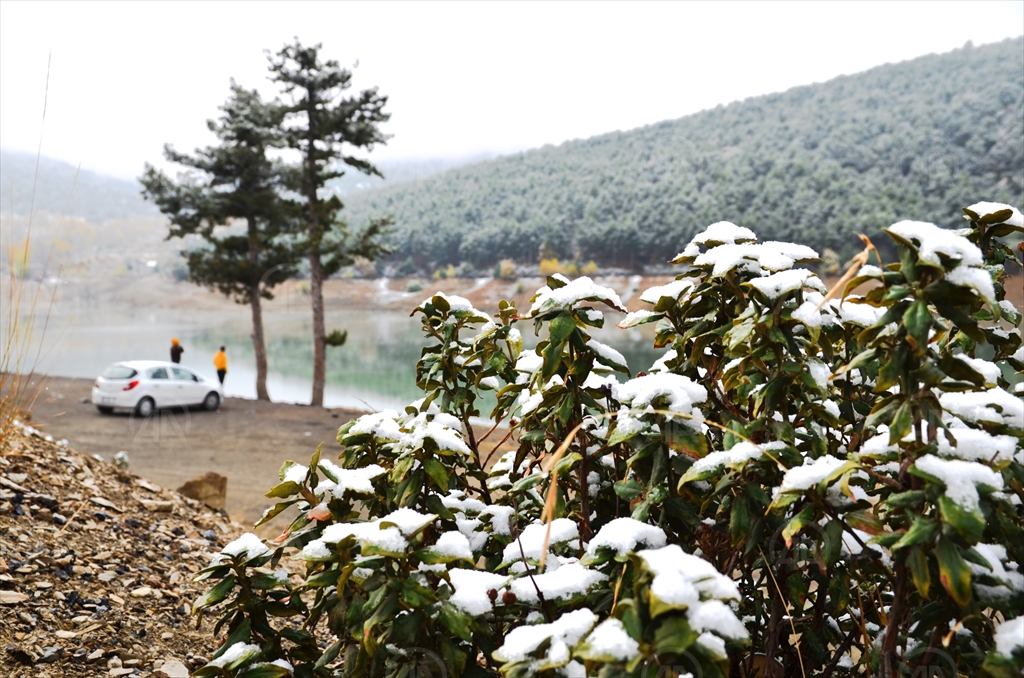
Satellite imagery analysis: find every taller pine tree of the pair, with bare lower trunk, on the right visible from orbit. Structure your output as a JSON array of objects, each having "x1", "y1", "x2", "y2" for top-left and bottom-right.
[{"x1": 267, "y1": 39, "x2": 391, "y2": 406}]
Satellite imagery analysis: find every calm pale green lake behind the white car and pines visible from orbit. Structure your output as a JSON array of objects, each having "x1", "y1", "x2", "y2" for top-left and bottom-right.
[{"x1": 24, "y1": 301, "x2": 663, "y2": 415}]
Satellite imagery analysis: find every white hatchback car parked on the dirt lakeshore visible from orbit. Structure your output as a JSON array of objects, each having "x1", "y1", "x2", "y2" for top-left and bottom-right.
[{"x1": 92, "y1": 361, "x2": 224, "y2": 417}]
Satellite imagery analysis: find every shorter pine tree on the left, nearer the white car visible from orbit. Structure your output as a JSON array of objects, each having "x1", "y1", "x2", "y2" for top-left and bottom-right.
[{"x1": 139, "y1": 81, "x2": 299, "y2": 400}]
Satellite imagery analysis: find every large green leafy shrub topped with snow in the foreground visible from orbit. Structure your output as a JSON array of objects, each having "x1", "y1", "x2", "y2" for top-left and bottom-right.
[{"x1": 195, "y1": 203, "x2": 1024, "y2": 678}]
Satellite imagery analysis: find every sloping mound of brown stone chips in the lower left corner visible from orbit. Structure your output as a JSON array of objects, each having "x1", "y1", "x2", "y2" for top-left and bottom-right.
[{"x1": 0, "y1": 427, "x2": 244, "y2": 678}]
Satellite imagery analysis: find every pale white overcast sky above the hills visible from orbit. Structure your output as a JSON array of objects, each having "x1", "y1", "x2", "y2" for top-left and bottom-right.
[{"x1": 0, "y1": 0, "x2": 1024, "y2": 178}]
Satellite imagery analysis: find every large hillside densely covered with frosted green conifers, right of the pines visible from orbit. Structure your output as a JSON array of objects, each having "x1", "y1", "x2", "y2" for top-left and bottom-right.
[{"x1": 347, "y1": 38, "x2": 1024, "y2": 268}]
